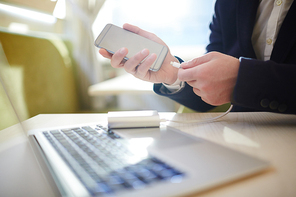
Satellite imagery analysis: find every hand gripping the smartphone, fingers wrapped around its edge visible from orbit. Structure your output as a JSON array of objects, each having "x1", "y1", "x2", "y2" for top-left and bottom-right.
[{"x1": 99, "y1": 24, "x2": 178, "y2": 84}]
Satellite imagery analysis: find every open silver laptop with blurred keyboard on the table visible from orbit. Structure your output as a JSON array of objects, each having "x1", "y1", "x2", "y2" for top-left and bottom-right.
[{"x1": 0, "y1": 45, "x2": 270, "y2": 197}]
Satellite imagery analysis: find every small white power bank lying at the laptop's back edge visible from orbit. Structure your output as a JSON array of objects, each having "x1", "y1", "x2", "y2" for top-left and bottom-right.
[{"x1": 108, "y1": 110, "x2": 160, "y2": 129}]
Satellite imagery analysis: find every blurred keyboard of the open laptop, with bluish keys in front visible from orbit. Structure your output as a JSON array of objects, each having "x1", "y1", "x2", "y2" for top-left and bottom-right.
[{"x1": 43, "y1": 125, "x2": 184, "y2": 196}]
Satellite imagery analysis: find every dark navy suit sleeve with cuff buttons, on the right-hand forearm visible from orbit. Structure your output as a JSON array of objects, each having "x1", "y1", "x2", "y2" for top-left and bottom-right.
[{"x1": 232, "y1": 58, "x2": 296, "y2": 114}]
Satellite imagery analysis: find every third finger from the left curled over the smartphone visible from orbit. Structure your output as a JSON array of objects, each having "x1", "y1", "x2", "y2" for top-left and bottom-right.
[{"x1": 124, "y1": 49, "x2": 149, "y2": 75}]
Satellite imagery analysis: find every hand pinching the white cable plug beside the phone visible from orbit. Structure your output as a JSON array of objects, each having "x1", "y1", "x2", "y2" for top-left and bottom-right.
[{"x1": 178, "y1": 52, "x2": 240, "y2": 106}]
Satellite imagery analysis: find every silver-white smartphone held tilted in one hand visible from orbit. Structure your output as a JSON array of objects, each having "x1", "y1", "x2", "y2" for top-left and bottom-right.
[{"x1": 95, "y1": 24, "x2": 168, "y2": 71}]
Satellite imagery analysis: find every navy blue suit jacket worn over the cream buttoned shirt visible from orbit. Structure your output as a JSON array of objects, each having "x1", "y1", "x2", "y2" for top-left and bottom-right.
[{"x1": 154, "y1": 0, "x2": 296, "y2": 114}]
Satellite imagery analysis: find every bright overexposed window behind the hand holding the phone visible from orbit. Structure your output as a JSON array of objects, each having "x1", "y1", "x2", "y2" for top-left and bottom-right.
[{"x1": 93, "y1": 0, "x2": 214, "y2": 60}]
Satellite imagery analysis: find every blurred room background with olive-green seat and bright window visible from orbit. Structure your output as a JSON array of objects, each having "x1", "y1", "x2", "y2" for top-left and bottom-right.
[{"x1": 0, "y1": 0, "x2": 214, "y2": 129}]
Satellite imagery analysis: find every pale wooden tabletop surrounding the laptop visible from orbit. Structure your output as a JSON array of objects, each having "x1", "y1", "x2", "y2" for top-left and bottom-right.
[{"x1": 0, "y1": 113, "x2": 296, "y2": 197}]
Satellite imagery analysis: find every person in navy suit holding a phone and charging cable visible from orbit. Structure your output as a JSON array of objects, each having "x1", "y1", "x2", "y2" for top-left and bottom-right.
[{"x1": 100, "y1": 0, "x2": 296, "y2": 114}]
